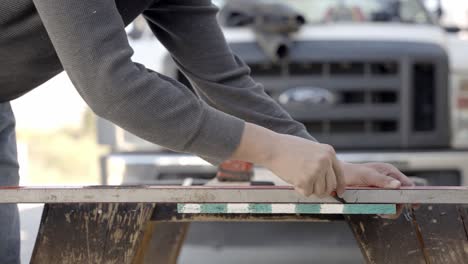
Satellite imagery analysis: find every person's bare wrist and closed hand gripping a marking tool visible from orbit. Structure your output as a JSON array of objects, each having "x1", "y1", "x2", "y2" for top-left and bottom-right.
[{"x1": 230, "y1": 122, "x2": 345, "y2": 196}]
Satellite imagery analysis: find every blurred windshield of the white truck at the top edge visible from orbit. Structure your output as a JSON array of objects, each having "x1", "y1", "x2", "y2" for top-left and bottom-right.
[{"x1": 221, "y1": 0, "x2": 432, "y2": 24}]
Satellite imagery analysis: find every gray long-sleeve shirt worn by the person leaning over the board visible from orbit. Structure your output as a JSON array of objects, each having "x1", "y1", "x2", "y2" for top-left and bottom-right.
[{"x1": 0, "y1": 0, "x2": 313, "y2": 162}]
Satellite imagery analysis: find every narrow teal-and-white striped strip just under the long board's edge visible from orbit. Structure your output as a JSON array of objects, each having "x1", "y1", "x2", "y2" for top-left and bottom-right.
[{"x1": 177, "y1": 203, "x2": 396, "y2": 214}]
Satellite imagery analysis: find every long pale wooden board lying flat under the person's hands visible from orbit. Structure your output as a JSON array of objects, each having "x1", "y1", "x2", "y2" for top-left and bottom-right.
[{"x1": 0, "y1": 186, "x2": 468, "y2": 204}]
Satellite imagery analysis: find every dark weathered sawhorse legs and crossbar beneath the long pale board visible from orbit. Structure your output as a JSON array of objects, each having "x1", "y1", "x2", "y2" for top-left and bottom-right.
[{"x1": 31, "y1": 203, "x2": 468, "y2": 264}]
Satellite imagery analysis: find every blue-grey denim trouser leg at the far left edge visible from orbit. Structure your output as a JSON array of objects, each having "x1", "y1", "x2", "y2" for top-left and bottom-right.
[{"x1": 0, "y1": 103, "x2": 20, "y2": 264}]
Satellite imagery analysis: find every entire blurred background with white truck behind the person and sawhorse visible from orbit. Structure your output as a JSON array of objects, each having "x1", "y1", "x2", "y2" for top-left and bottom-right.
[{"x1": 12, "y1": 0, "x2": 468, "y2": 263}]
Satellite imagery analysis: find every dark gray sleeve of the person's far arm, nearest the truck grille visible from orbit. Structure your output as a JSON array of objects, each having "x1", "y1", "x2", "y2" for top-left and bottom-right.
[{"x1": 143, "y1": 0, "x2": 315, "y2": 141}]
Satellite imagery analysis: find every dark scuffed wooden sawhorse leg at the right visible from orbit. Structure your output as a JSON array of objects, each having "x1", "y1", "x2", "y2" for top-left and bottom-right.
[{"x1": 346, "y1": 205, "x2": 468, "y2": 264}]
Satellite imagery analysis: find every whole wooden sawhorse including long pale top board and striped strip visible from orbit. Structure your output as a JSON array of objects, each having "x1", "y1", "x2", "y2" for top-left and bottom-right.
[{"x1": 0, "y1": 186, "x2": 468, "y2": 264}]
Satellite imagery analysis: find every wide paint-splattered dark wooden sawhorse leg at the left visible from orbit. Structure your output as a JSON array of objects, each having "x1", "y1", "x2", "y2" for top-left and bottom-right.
[{"x1": 31, "y1": 203, "x2": 154, "y2": 264}]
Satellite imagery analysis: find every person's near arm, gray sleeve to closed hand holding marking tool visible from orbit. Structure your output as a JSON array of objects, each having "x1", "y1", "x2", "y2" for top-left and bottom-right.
[{"x1": 33, "y1": 0, "x2": 406, "y2": 198}]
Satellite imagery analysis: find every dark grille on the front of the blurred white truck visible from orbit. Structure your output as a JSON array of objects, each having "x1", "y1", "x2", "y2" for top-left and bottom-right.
[{"x1": 238, "y1": 43, "x2": 449, "y2": 150}]
